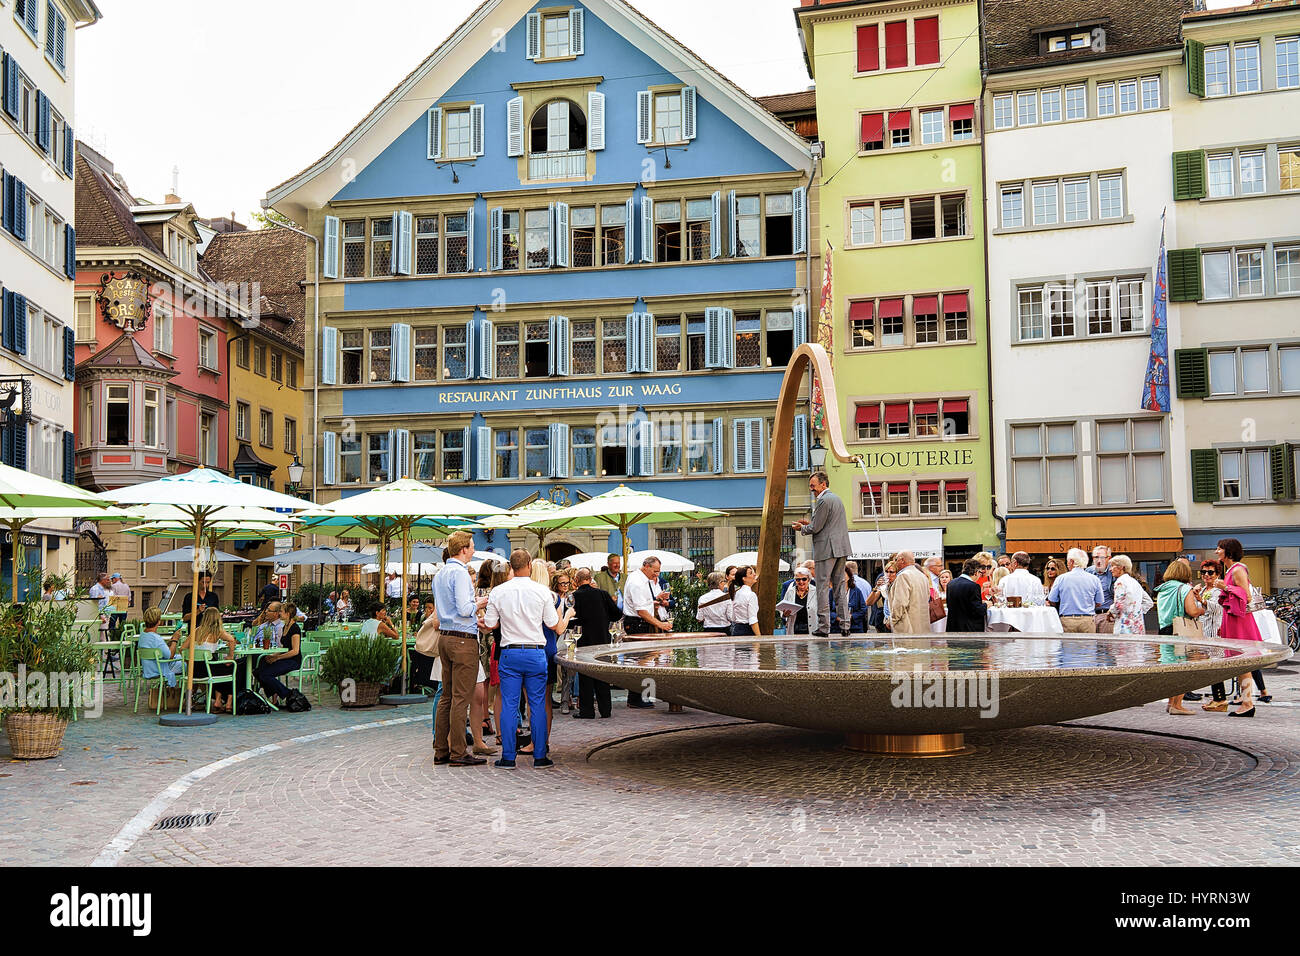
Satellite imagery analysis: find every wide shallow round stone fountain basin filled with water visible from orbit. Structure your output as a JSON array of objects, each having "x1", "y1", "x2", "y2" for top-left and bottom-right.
[{"x1": 559, "y1": 633, "x2": 1291, "y2": 734}]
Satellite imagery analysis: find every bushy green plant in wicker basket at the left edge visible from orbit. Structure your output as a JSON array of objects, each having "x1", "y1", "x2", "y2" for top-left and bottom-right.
[{"x1": 0, "y1": 568, "x2": 99, "y2": 760}]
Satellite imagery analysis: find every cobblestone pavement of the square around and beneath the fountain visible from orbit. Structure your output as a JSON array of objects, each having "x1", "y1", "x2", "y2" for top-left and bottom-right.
[{"x1": 0, "y1": 667, "x2": 1300, "y2": 865}]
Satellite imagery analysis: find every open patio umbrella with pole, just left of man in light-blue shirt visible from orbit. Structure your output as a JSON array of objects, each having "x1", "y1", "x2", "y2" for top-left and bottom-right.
[{"x1": 303, "y1": 477, "x2": 502, "y2": 704}]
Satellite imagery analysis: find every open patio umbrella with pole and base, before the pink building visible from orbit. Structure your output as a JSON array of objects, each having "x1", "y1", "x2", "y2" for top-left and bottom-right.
[{"x1": 104, "y1": 468, "x2": 312, "y2": 726}]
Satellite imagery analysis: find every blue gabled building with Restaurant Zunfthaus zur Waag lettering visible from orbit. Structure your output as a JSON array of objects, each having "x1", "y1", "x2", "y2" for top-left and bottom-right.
[{"x1": 267, "y1": 0, "x2": 819, "y2": 564}]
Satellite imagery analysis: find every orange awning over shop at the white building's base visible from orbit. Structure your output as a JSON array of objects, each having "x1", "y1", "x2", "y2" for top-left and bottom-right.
[{"x1": 1006, "y1": 514, "x2": 1183, "y2": 554}]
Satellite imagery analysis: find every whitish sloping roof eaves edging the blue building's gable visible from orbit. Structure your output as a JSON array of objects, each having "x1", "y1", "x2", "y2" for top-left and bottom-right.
[{"x1": 263, "y1": 0, "x2": 811, "y2": 221}]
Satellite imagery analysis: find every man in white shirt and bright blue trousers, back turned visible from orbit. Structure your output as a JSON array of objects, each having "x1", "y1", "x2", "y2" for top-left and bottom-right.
[{"x1": 484, "y1": 550, "x2": 560, "y2": 769}]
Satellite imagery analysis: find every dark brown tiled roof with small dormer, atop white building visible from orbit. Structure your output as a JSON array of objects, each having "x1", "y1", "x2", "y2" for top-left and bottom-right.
[{"x1": 984, "y1": 0, "x2": 1193, "y2": 73}]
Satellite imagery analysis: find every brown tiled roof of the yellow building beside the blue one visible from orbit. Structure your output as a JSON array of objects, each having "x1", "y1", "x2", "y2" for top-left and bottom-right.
[{"x1": 202, "y1": 226, "x2": 308, "y2": 349}]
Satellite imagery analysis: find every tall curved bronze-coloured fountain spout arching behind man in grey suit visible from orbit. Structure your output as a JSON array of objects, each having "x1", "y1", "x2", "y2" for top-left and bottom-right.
[{"x1": 758, "y1": 343, "x2": 861, "y2": 631}]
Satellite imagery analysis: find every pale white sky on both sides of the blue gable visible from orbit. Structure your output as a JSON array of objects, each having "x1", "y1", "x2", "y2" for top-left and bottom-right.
[{"x1": 75, "y1": 0, "x2": 811, "y2": 225}]
